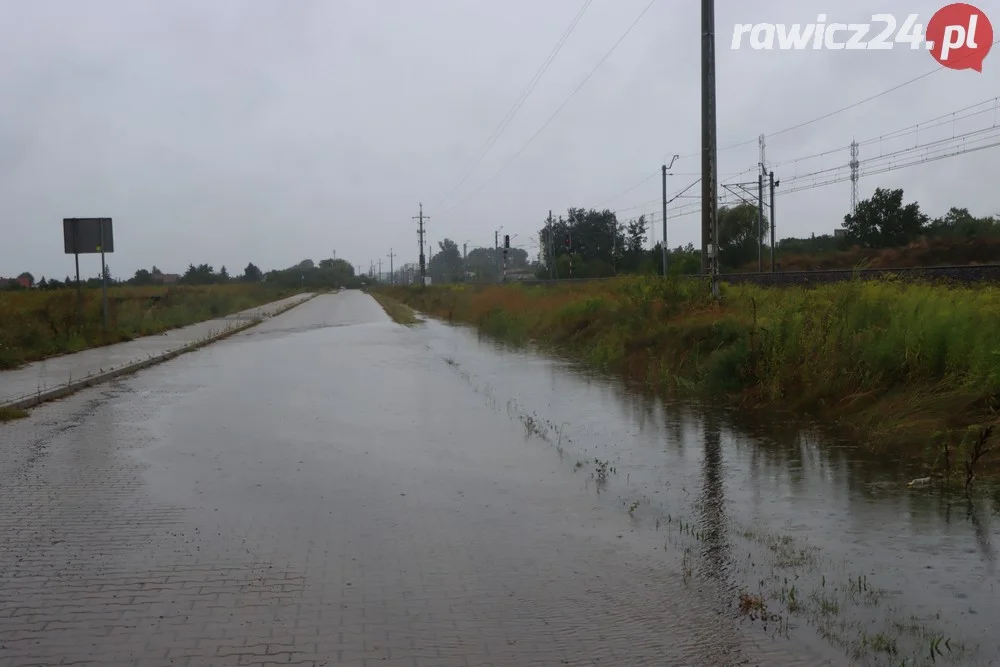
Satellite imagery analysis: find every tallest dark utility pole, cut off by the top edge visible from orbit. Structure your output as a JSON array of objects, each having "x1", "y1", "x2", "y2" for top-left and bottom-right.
[{"x1": 701, "y1": 0, "x2": 719, "y2": 298}]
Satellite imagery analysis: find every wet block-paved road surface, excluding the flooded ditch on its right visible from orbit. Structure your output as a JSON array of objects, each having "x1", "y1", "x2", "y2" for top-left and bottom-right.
[{"x1": 0, "y1": 292, "x2": 840, "y2": 667}]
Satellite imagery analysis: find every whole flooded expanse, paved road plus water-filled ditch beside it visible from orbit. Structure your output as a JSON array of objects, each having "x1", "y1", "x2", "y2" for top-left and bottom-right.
[{"x1": 0, "y1": 292, "x2": 1000, "y2": 667}]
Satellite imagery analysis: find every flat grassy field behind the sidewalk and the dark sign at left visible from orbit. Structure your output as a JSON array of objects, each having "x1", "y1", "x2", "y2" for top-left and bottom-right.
[{"x1": 0, "y1": 285, "x2": 296, "y2": 370}]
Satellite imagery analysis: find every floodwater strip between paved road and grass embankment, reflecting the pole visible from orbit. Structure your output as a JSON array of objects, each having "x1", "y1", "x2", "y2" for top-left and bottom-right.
[{"x1": 413, "y1": 321, "x2": 1000, "y2": 666}]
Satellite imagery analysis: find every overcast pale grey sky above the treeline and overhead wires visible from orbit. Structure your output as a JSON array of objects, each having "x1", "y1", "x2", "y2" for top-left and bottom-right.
[{"x1": 0, "y1": 0, "x2": 1000, "y2": 277}]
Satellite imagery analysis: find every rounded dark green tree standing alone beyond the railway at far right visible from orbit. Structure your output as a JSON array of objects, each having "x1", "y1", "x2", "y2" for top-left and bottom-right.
[{"x1": 844, "y1": 188, "x2": 928, "y2": 248}]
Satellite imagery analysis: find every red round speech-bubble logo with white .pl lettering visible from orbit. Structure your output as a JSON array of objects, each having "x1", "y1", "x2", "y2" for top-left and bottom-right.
[{"x1": 926, "y1": 2, "x2": 993, "y2": 72}]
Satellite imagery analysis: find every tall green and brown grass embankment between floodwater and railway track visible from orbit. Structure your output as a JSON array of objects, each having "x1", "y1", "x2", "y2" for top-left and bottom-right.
[{"x1": 387, "y1": 278, "x2": 1000, "y2": 479}]
